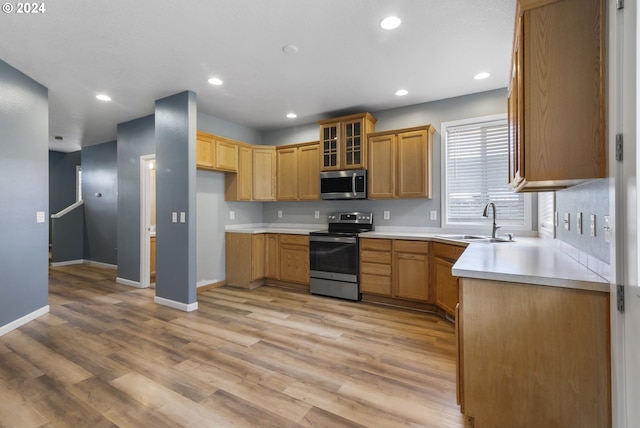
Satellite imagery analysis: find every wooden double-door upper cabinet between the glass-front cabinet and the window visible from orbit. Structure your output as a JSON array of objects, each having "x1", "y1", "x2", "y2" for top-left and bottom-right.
[{"x1": 368, "y1": 125, "x2": 435, "y2": 199}]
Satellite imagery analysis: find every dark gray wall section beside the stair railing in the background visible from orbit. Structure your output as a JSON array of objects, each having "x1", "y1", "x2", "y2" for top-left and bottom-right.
[{"x1": 82, "y1": 141, "x2": 118, "y2": 265}]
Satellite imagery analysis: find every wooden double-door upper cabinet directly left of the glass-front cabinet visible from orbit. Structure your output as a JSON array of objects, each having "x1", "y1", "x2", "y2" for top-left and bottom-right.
[{"x1": 276, "y1": 141, "x2": 320, "y2": 201}]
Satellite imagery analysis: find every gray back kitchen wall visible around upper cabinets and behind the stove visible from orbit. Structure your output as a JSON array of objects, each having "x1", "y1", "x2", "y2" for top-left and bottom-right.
[{"x1": 262, "y1": 89, "x2": 510, "y2": 231}]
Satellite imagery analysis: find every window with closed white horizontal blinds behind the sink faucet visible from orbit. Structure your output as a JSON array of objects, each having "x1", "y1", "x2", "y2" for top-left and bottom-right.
[{"x1": 443, "y1": 115, "x2": 526, "y2": 226}]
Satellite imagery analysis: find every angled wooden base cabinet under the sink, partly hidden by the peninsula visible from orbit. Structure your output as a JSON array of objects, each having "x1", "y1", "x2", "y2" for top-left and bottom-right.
[{"x1": 433, "y1": 242, "x2": 465, "y2": 315}]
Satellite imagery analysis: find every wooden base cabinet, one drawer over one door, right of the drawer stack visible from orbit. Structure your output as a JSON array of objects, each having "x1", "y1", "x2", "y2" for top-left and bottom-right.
[{"x1": 391, "y1": 240, "x2": 431, "y2": 302}]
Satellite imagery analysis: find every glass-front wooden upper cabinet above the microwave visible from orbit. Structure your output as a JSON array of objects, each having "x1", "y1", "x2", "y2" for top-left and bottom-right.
[{"x1": 318, "y1": 113, "x2": 376, "y2": 171}]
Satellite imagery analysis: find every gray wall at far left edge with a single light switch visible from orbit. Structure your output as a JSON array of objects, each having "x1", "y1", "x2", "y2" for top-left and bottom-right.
[{"x1": 0, "y1": 60, "x2": 49, "y2": 327}]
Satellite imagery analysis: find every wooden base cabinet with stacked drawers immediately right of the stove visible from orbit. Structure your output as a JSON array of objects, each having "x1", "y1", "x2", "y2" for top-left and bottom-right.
[{"x1": 360, "y1": 238, "x2": 392, "y2": 297}]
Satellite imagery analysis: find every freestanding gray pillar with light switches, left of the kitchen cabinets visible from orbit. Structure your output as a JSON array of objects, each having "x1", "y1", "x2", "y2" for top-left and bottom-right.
[{"x1": 155, "y1": 91, "x2": 197, "y2": 305}]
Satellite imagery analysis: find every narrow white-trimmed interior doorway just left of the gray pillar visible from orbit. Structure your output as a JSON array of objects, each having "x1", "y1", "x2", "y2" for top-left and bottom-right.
[{"x1": 140, "y1": 154, "x2": 156, "y2": 288}]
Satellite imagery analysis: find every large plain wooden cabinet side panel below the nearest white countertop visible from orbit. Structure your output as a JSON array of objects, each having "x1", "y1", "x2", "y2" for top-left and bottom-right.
[{"x1": 456, "y1": 278, "x2": 612, "y2": 428}]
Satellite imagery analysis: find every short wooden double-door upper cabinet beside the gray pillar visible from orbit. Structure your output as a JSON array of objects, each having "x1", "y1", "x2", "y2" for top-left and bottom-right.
[{"x1": 196, "y1": 131, "x2": 241, "y2": 172}]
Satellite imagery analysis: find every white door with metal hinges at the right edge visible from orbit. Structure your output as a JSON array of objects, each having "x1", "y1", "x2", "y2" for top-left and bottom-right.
[{"x1": 608, "y1": 0, "x2": 640, "y2": 428}]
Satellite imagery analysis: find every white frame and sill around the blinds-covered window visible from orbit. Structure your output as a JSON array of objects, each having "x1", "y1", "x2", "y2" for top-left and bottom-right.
[{"x1": 440, "y1": 113, "x2": 533, "y2": 232}]
